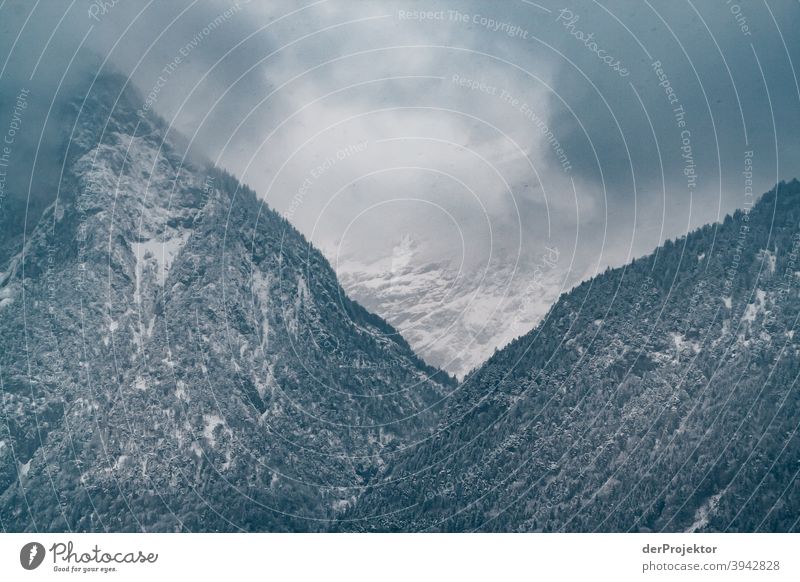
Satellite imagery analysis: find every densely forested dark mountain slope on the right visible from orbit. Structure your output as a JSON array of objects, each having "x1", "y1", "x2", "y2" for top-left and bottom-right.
[{"x1": 340, "y1": 180, "x2": 800, "y2": 532}]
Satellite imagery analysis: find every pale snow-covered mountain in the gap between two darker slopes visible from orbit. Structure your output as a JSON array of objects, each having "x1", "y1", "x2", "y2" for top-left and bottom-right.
[{"x1": 337, "y1": 235, "x2": 564, "y2": 378}]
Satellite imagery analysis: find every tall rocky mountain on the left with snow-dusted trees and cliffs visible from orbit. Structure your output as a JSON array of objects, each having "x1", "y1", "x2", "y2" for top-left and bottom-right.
[{"x1": 0, "y1": 75, "x2": 454, "y2": 531}]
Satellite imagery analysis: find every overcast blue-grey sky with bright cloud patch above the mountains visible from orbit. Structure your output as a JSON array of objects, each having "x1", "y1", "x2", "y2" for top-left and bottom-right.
[{"x1": 0, "y1": 0, "x2": 800, "y2": 312}]
